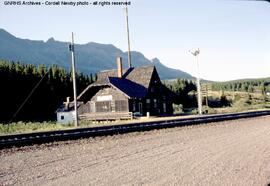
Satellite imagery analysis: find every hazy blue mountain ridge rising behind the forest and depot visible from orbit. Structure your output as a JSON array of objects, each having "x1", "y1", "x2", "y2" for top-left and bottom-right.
[{"x1": 0, "y1": 28, "x2": 193, "y2": 80}]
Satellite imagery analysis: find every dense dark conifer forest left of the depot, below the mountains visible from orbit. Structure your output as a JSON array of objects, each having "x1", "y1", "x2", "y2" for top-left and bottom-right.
[{"x1": 0, "y1": 60, "x2": 96, "y2": 123}]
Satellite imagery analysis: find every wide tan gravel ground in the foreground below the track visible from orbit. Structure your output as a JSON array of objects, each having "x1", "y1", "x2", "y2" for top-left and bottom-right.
[{"x1": 0, "y1": 116, "x2": 270, "y2": 186}]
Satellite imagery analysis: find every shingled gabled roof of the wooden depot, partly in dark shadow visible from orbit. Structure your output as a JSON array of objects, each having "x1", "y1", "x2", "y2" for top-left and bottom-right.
[{"x1": 78, "y1": 66, "x2": 155, "y2": 100}]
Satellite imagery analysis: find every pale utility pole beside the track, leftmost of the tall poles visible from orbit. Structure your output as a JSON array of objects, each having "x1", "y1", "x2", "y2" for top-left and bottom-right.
[{"x1": 69, "y1": 32, "x2": 78, "y2": 127}]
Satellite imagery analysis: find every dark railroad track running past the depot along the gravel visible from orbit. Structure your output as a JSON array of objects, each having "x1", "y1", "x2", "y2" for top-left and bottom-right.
[{"x1": 0, "y1": 110, "x2": 270, "y2": 149}]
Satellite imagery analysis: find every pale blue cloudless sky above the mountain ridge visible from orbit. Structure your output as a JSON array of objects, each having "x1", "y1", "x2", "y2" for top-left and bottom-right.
[{"x1": 0, "y1": 0, "x2": 270, "y2": 81}]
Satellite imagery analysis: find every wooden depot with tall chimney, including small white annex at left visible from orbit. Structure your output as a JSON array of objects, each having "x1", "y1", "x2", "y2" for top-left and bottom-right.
[{"x1": 57, "y1": 57, "x2": 173, "y2": 123}]
